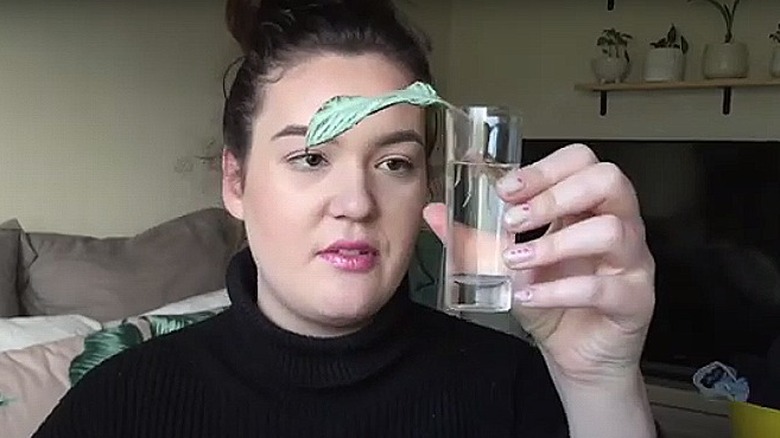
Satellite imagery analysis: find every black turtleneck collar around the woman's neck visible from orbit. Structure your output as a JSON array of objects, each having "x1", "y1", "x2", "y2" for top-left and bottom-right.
[{"x1": 227, "y1": 248, "x2": 413, "y2": 388}]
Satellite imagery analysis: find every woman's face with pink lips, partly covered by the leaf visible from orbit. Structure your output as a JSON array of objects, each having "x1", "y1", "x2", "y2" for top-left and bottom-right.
[{"x1": 223, "y1": 54, "x2": 427, "y2": 336}]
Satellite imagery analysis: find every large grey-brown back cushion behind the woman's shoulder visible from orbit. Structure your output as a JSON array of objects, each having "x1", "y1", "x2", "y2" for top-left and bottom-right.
[{"x1": 19, "y1": 208, "x2": 243, "y2": 322}]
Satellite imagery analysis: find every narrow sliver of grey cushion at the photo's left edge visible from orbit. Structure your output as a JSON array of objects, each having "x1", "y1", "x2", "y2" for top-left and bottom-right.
[{"x1": 0, "y1": 220, "x2": 21, "y2": 317}]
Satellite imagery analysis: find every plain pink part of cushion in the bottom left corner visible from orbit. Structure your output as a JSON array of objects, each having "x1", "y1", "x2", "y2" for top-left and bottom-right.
[{"x1": 0, "y1": 336, "x2": 84, "y2": 438}]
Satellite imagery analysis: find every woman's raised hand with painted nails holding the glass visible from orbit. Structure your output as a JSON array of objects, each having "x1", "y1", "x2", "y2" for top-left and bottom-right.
[{"x1": 425, "y1": 144, "x2": 655, "y2": 387}]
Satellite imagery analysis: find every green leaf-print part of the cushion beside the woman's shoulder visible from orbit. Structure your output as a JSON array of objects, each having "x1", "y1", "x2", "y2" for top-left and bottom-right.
[{"x1": 69, "y1": 308, "x2": 225, "y2": 385}]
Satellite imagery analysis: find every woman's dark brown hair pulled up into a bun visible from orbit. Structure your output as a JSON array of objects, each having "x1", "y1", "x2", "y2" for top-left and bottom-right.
[{"x1": 222, "y1": 0, "x2": 435, "y2": 168}]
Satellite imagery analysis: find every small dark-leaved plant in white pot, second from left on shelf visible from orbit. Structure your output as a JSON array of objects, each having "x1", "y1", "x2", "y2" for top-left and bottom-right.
[{"x1": 643, "y1": 23, "x2": 689, "y2": 82}]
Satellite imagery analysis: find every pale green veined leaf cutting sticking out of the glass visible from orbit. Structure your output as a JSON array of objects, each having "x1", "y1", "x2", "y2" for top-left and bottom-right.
[{"x1": 306, "y1": 81, "x2": 452, "y2": 147}]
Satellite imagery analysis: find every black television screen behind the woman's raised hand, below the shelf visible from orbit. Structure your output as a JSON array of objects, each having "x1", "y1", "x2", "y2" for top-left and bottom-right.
[{"x1": 523, "y1": 139, "x2": 780, "y2": 381}]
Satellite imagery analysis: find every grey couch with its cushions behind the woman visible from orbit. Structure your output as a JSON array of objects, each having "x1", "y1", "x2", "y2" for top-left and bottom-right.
[{"x1": 0, "y1": 208, "x2": 442, "y2": 438}]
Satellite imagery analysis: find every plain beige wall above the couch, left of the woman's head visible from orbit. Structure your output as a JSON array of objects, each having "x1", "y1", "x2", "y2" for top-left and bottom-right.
[{"x1": 0, "y1": 0, "x2": 237, "y2": 236}]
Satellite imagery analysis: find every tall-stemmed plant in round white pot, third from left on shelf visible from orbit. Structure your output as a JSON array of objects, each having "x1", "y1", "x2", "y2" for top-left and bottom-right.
[{"x1": 688, "y1": 0, "x2": 750, "y2": 79}]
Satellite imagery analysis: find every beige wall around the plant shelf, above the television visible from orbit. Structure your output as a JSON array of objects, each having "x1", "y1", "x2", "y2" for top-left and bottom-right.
[{"x1": 447, "y1": 0, "x2": 780, "y2": 139}]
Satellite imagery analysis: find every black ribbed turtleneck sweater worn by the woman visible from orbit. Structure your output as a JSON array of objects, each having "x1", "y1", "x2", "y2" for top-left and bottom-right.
[{"x1": 35, "y1": 250, "x2": 568, "y2": 438}]
